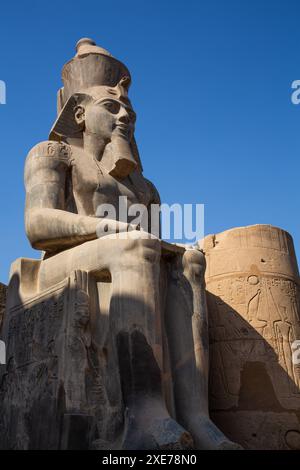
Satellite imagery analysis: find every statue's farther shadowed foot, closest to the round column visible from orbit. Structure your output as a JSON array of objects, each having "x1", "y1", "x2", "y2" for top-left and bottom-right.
[{"x1": 188, "y1": 414, "x2": 243, "y2": 450}]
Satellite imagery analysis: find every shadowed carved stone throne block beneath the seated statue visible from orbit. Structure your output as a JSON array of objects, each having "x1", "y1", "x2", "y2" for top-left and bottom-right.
[{"x1": 0, "y1": 272, "x2": 95, "y2": 449}]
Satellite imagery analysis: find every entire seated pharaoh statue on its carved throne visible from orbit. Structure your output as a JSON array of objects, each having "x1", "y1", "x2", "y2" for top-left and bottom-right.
[{"x1": 0, "y1": 38, "x2": 240, "y2": 450}]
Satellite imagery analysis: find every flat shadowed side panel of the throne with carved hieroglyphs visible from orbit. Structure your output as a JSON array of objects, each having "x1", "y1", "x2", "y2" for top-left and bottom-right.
[{"x1": 0, "y1": 283, "x2": 67, "y2": 449}]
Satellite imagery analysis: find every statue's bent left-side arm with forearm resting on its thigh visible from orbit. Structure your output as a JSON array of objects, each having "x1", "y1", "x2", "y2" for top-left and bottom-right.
[{"x1": 25, "y1": 143, "x2": 134, "y2": 252}]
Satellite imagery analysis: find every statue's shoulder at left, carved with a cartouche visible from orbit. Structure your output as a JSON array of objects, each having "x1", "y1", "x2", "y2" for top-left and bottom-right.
[{"x1": 26, "y1": 140, "x2": 71, "y2": 166}]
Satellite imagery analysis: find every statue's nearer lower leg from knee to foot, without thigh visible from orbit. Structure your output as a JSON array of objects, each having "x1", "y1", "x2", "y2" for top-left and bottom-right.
[{"x1": 110, "y1": 239, "x2": 192, "y2": 449}]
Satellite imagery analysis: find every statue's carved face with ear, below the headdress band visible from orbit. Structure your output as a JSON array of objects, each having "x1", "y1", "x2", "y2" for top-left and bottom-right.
[{"x1": 75, "y1": 97, "x2": 136, "y2": 141}]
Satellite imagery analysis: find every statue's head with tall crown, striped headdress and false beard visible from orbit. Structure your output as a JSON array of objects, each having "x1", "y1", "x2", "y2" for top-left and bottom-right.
[{"x1": 50, "y1": 38, "x2": 141, "y2": 172}]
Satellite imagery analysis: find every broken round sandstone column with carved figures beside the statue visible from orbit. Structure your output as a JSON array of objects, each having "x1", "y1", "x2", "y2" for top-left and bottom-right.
[{"x1": 204, "y1": 225, "x2": 300, "y2": 449}]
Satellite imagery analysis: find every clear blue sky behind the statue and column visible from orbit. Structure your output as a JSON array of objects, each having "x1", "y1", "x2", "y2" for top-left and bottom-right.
[{"x1": 0, "y1": 0, "x2": 300, "y2": 282}]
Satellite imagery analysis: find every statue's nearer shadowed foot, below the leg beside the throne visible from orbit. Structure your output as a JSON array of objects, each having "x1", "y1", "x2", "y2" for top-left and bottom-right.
[{"x1": 122, "y1": 409, "x2": 194, "y2": 450}]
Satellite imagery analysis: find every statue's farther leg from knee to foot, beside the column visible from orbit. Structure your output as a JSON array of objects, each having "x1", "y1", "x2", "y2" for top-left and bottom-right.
[{"x1": 166, "y1": 250, "x2": 240, "y2": 450}]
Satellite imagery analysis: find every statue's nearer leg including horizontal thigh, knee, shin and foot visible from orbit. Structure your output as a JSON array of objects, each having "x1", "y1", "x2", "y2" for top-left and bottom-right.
[{"x1": 40, "y1": 232, "x2": 192, "y2": 449}]
